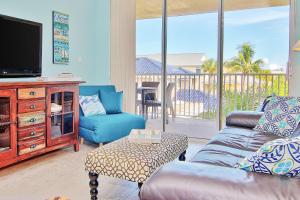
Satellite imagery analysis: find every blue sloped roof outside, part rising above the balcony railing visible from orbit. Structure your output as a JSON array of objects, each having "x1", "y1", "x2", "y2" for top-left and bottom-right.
[{"x1": 136, "y1": 57, "x2": 193, "y2": 75}]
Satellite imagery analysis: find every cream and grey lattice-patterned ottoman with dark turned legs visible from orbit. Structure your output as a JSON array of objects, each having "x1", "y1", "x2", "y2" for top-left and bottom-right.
[{"x1": 85, "y1": 133, "x2": 188, "y2": 200}]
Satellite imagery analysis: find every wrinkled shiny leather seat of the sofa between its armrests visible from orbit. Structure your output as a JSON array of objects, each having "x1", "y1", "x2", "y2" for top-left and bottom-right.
[{"x1": 191, "y1": 127, "x2": 279, "y2": 167}]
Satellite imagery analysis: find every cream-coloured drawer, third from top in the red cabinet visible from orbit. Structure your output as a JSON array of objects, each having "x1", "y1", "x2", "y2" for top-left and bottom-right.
[{"x1": 18, "y1": 112, "x2": 45, "y2": 127}]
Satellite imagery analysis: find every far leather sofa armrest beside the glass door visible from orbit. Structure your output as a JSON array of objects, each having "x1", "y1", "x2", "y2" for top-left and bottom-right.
[{"x1": 226, "y1": 111, "x2": 263, "y2": 129}]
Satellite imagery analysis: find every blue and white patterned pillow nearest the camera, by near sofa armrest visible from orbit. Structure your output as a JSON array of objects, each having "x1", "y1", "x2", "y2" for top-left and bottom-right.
[{"x1": 236, "y1": 137, "x2": 300, "y2": 178}]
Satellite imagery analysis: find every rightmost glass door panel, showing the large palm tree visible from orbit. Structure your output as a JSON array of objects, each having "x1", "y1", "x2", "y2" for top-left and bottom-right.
[{"x1": 221, "y1": 0, "x2": 290, "y2": 125}]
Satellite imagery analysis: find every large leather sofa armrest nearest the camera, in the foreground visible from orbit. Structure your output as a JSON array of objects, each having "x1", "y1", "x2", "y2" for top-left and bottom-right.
[{"x1": 140, "y1": 161, "x2": 300, "y2": 200}]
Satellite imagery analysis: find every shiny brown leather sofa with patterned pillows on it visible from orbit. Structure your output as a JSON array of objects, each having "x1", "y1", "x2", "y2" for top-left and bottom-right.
[{"x1": 140, "y1": 112, "x2": 300, "y2": 200}]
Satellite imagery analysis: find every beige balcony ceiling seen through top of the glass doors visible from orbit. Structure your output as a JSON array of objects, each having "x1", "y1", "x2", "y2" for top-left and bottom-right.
[{"x1": 136, "y1": 0, "x2": 289, "y2": 19}]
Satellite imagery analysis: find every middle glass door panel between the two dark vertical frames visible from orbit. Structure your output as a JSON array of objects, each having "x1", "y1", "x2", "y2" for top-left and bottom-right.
[{"x1": 166, "y1": 0, "x2": 218, "y2": 139}]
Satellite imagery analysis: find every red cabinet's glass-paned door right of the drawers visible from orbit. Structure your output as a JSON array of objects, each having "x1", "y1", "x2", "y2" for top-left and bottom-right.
[{"x1": 47, "y1": 87, "x2": 79, "y2": 146}]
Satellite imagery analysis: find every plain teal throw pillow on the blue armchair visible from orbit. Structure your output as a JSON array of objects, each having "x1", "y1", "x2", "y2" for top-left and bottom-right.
[{"x1": 100, "y1": 91, "x2": 123, "y2": 114}]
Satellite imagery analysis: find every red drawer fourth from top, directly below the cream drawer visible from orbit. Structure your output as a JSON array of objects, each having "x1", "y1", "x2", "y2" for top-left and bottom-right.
[{"x1": 18, "y1": 126, "x2": 46, "y2": 141}]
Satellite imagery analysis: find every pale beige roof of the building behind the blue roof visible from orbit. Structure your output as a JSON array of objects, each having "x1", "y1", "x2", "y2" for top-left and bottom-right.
[{"x1": 138, "y1": 53, "x2": 207, "y2": 67}]
